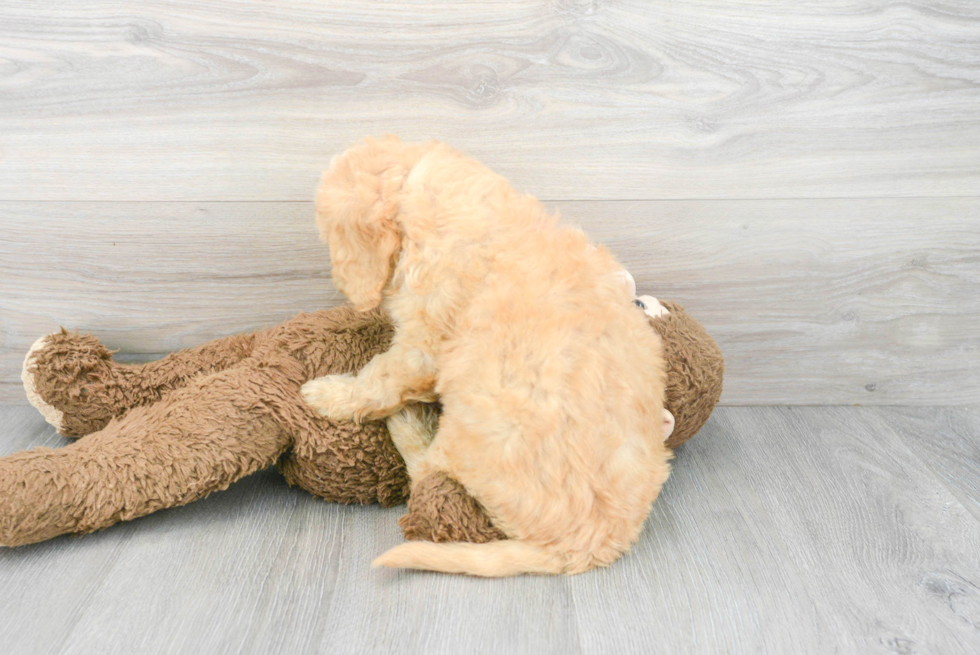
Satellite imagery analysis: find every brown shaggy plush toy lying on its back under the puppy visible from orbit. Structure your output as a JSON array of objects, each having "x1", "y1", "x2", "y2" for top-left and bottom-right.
[{"x1": 0, "y1": 299, "x2": 723, "y2": 546}]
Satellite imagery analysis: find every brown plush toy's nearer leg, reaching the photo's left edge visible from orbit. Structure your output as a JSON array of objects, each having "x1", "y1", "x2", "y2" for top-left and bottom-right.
[{"x1": 0, "y1": 362, "x2": 290, "y2": 546}]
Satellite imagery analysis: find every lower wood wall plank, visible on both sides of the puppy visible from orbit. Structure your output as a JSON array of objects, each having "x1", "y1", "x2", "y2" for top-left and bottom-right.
[{"x1": 0, "y1": 198, "x2": 980, "y2": 405}]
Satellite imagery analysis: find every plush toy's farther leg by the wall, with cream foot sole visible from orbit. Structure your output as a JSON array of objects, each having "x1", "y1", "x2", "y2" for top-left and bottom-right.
[{"x1": 21, "y1": 330, "x2": 255, "y2": 437}]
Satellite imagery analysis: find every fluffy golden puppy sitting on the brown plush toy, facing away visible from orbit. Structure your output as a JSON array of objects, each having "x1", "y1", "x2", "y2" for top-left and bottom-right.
[{"x1": 303, "y1": 136, "x2": 670, "y2": 576}]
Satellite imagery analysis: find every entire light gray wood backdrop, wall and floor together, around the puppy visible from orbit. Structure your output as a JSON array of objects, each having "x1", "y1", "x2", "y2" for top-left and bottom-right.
[{"x1": 0, "y1": 0, "x2": 980, "y2": 654}]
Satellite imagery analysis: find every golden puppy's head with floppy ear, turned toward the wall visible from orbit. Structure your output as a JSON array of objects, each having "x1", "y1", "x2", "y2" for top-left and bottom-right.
[{"x1": 316, "y1": 136, "x2": 425, "y2": 311}]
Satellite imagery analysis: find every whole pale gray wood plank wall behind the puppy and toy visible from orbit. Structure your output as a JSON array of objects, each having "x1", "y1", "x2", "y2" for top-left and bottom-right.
[{"x1": 0, "y1": 0, "x2": 980, "y2": 405}]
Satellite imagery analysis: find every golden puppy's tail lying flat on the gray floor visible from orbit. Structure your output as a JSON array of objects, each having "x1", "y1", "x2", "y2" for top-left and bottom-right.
[{"x1": 372, "y1": 539, "x2": 568, "y2": 578}]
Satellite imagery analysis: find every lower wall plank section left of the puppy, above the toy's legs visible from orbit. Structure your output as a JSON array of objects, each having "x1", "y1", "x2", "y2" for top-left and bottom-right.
[{"x1": 0, "y1": 203, "x2": 334, "y2": 402}]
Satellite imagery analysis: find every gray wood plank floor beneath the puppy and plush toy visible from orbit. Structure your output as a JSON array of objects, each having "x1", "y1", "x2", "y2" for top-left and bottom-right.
[{"x1": 0, "y1": 407, "x2": 980, "y2": 654}]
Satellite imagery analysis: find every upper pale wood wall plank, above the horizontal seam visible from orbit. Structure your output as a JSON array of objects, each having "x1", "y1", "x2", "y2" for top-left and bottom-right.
[{"x1": 0, "y1": 0, "x2": 980, "y2": 201}]
